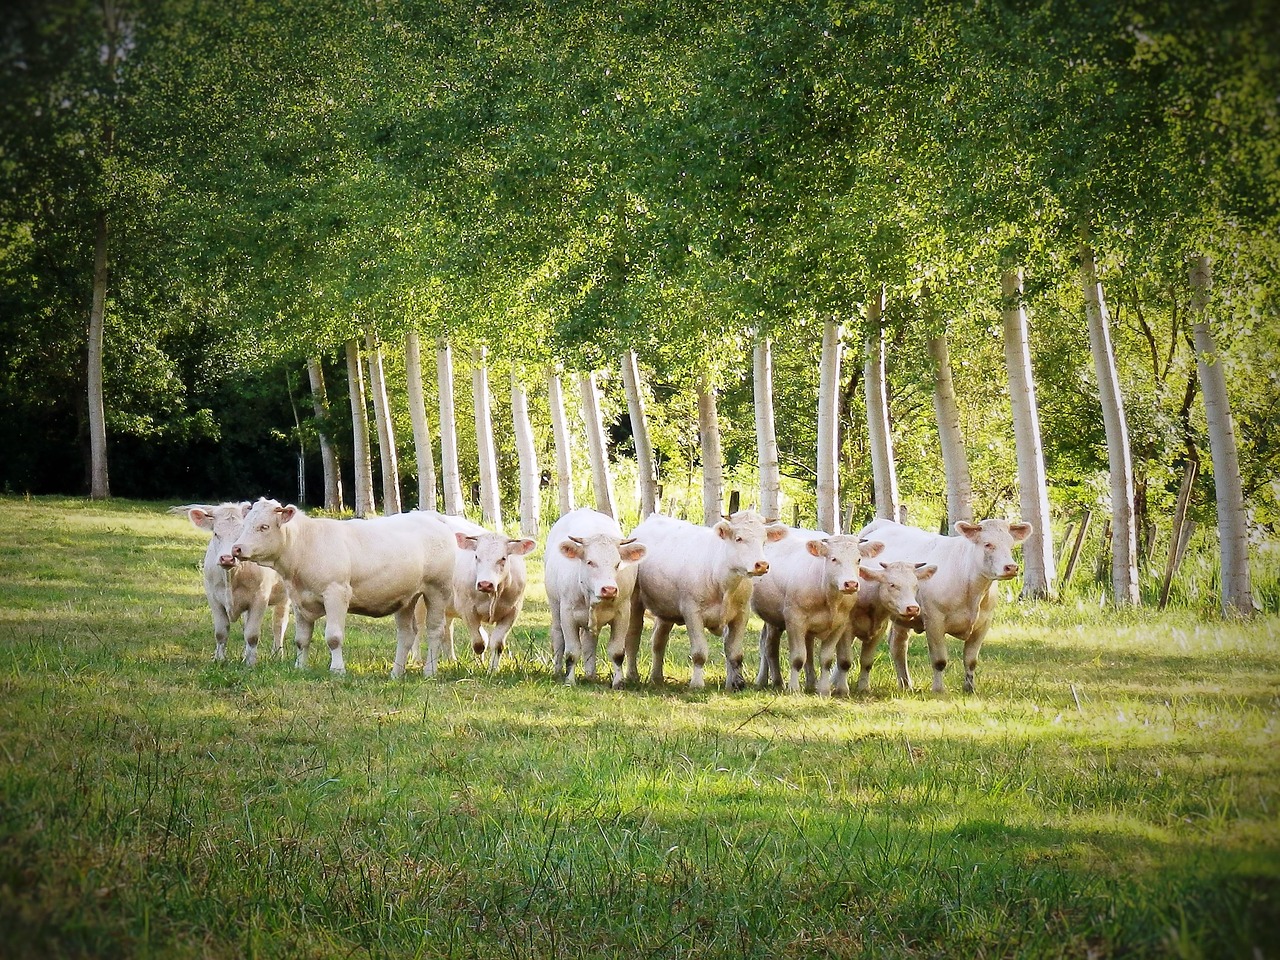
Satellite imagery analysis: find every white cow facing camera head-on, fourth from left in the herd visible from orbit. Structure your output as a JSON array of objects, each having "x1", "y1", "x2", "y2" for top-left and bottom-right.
[{"x1": 544, "y1": 508, "x2": 645, "y2": 689}]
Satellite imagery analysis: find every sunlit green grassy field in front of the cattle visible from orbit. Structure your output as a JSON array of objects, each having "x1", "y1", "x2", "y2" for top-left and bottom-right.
[{"x1": 0, "y1": 498, "x2": 1280, "y2": 957}]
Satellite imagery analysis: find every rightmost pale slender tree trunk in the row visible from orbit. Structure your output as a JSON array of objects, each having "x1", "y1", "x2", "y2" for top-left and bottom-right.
[{"x1": 1192, "y1": 256, "x2": 1254, "y2": 617}]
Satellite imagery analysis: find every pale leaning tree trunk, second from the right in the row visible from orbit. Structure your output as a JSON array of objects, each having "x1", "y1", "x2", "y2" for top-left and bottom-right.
[{"x1": 1080, "y1": 242, "x2": 1139, "y2": 605}]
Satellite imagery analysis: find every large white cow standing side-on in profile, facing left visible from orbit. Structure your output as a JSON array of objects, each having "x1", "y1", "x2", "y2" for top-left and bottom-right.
[{"x1": 232, "y1": 499, "x2": 457, "y2": 677}]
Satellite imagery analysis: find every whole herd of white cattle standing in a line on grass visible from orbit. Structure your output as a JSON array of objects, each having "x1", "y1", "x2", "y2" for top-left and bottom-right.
[{"x1": 174, "y1": 499, "x2": 1032, "y2": 695}]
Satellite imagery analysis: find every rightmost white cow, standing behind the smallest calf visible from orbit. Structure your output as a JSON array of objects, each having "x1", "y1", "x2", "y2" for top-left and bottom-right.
[{"x1": 861, "y1": 520, "x2": 1032, "y2": 694}]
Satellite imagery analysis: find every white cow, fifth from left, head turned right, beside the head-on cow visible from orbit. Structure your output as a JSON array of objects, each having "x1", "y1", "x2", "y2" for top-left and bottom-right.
[{"x1": 626, "y1": 509, "x2": 788, "y2": 690}]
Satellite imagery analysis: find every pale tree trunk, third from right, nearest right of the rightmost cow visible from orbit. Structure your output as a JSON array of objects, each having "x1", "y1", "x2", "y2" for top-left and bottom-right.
[{"x1": 1001, "y1": 269, "x2": 1057, "y2": 599}]
